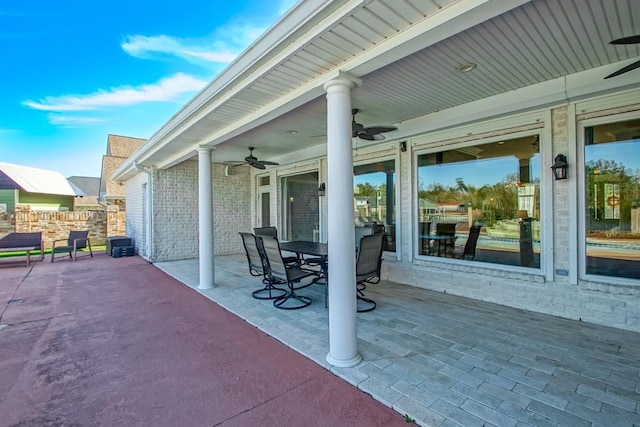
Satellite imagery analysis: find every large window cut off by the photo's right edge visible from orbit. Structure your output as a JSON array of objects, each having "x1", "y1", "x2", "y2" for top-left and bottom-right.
[{"x1": 584, "y1": 120, "x2": 640, "y2": 279}]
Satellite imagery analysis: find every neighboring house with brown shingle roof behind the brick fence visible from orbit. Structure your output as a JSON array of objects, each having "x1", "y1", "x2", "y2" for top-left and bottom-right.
[{"x1": 98, "y1": 135, "x2": 146, "y2": 209}]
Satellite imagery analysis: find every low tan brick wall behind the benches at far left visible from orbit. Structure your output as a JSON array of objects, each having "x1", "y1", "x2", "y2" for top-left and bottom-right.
[{"x1": 2, "y1": 206, "x2": 126, "y2": 248}]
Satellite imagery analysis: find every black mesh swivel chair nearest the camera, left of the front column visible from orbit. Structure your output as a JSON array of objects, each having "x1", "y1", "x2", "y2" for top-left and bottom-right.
[{"x1": 262, "y1": 237, "x2": 315, "y2": 310}]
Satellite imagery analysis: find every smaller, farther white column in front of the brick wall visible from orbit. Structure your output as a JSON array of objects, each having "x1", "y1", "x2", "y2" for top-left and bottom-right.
[{"x1": 198, "y1": 147, "x2": 214, "y2": 289}]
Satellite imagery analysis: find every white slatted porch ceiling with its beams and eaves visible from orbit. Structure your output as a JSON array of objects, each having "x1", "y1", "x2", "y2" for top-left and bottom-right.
[{"x1": 125, "y1": 0, "x2": 640, "y2": 175}]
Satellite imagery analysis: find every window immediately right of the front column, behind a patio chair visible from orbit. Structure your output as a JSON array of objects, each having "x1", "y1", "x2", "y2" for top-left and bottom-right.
[{"x1": 353, "y1": 160, "x2": 396, "y2": 252}]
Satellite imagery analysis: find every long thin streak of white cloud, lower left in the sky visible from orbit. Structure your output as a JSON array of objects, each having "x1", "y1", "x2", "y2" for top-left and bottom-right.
[{"x1": 22, "y1": 73, "x2": 207, "y2": 112}]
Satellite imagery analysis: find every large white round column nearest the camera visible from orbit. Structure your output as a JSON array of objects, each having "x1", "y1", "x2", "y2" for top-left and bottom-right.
[{"x1": 324, "y1": 77, "x2": 362, "y2": 367}]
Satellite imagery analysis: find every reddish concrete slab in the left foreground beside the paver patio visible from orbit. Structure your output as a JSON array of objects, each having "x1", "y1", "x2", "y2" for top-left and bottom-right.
[{"x1": 0, "y1": 253, "x2": 406, "y2": 426}]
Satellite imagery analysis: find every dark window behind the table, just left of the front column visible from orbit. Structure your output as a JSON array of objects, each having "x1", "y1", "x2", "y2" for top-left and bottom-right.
[{"x1": 279, "y1": 172, "x2": 320, "y2": 241}]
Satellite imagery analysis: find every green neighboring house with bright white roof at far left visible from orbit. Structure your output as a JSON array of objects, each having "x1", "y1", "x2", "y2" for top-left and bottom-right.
[{"x1": 0, "y1": 163, "x2": 84, "y2": 212}]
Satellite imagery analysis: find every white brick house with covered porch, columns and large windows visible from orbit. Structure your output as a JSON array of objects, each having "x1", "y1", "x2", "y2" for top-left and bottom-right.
[{"x1": 113, "y1": 0, "x2": 640, "y2": 372}]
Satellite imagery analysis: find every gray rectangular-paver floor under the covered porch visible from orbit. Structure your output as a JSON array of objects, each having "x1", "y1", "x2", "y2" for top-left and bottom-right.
[{"x1": 156, "y1": 256, "x2": 640, "y2": 426}]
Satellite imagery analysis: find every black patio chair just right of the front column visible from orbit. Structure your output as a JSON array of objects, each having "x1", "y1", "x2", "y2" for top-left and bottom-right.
[{"x1": 356, "y1": 234, "x2": 385, "y2": 313}]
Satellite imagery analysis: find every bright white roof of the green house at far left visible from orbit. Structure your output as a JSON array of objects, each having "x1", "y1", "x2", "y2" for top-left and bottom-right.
[{"x1": 0, "y1": 162, "x2": 84, "y2": 196}]
